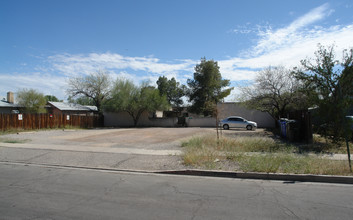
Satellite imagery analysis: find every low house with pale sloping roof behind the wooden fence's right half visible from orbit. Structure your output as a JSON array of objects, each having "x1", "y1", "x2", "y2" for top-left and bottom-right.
[{"x1": 47, "y1": 102, "x2": 98, "y2": 115}]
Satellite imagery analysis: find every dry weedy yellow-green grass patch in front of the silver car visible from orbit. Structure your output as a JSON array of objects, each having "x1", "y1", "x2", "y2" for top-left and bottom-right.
[{"x1": 182, "y1": 135, "x2": 353, "y2": 176}]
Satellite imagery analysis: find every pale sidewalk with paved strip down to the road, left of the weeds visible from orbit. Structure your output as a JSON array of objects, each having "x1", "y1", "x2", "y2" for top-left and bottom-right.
[{"x1": 0, "y1": 143, "x2": 186, "y2": 171}]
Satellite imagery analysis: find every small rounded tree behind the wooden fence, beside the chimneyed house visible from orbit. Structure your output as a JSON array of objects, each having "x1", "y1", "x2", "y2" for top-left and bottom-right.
[{"x1": 16, "y1": 89, "x2": 47, "y2": 113}]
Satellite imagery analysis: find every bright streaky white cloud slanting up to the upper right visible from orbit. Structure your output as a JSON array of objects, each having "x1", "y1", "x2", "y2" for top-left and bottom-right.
[{"x1": 218, "y1": 4, "x2": 353, "y2": 87}]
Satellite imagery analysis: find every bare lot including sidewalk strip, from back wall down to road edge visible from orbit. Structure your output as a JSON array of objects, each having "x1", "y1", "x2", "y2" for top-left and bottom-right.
[{"x1": 0, "y1": 128, "x2": 263, "y2": 171}]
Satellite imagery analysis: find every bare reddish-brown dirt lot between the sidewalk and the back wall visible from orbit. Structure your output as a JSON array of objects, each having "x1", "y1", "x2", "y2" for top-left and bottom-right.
[{"x1": 0, "y1": 128, "x2": 264, "y2": 150}]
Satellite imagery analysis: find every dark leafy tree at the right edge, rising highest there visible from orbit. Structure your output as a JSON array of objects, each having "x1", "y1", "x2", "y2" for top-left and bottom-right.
[{"x1": 295, "y1": 45, "x2": 353, "y2": 142}]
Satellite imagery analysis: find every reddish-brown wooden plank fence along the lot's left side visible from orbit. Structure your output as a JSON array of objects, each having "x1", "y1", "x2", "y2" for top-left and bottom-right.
[{"x1": 0, "y1": 114, "x2": 103, "y2": 131}]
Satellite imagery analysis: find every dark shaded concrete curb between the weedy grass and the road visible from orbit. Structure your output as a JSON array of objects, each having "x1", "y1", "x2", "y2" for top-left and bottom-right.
[{"x1": 155, "y1": 170, "x2": 353, "y2": 184}]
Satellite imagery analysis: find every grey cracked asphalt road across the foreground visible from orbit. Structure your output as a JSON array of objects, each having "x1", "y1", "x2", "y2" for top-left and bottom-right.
[{"x1": 0, "y1": 163, "x2": 353, "y2": 220}]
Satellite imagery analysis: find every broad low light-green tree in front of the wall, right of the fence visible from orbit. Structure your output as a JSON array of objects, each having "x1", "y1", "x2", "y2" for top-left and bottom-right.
[{"x1": 105, "y1": 79, "x2": 168, "y2": 127}]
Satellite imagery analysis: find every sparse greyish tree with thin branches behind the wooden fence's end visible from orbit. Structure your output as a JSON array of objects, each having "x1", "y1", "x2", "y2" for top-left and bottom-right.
[{"x1": 67, "y1": 70, "x2": 111, "y2": 114}]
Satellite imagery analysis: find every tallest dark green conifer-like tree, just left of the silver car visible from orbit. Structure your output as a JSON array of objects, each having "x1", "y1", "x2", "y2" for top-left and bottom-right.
[{"x1": 187, "y1": 58, "x2": 233, "y2": 116}]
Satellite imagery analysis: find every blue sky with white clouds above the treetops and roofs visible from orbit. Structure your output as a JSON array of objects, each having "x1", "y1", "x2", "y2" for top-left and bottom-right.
[{"x1": 0, "y1": 0, "x2": 353, "y2": 100}]
